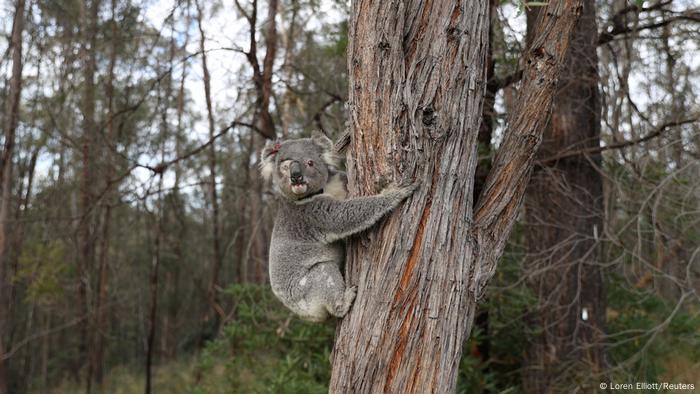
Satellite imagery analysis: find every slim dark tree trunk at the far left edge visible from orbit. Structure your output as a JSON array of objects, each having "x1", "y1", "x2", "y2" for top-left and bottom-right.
[{"x1": 0, "y1": 0, "x2": 24, "y2": 394}]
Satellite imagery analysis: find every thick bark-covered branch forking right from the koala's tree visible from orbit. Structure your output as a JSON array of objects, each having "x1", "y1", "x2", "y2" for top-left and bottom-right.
[{"x1": 474, "y1": 0, "x2": 582, "y2": 270}]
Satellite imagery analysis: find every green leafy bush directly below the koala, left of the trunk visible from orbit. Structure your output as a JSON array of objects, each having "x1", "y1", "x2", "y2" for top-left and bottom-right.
[{"x1": 191, "y1": 285, "x2": 335, "y2": 394}]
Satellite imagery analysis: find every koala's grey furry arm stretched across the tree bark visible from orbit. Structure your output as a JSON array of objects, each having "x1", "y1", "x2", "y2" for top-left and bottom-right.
[{"x1": 309, "y1": 186, "x2": 415, "y2": 243}]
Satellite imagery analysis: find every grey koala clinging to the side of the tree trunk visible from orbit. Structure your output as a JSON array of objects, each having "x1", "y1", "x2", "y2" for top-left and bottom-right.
[{"x1": 260, "y1": 132, "x2": 416, "y2": 322}]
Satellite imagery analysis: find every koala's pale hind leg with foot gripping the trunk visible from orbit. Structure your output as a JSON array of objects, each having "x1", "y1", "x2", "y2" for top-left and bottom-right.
[{"x1": 313, "y1": 262, "x2": 357, "y2": 317}]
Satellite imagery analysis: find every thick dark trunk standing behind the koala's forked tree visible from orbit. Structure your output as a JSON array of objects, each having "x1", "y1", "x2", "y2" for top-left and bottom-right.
[{"x1": 523, "y1": 0, "x2": 605, "y2": 393}]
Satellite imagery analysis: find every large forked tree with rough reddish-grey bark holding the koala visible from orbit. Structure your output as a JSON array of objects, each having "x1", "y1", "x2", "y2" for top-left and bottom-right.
[{"x1": 329, "y1": 0, "x2": 580, "y2": 393}]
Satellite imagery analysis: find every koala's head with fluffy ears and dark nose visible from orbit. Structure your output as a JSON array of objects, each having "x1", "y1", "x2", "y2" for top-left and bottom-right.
[{"x1": 260, "y1": 132, "x2": 338, "y2": 200}]
